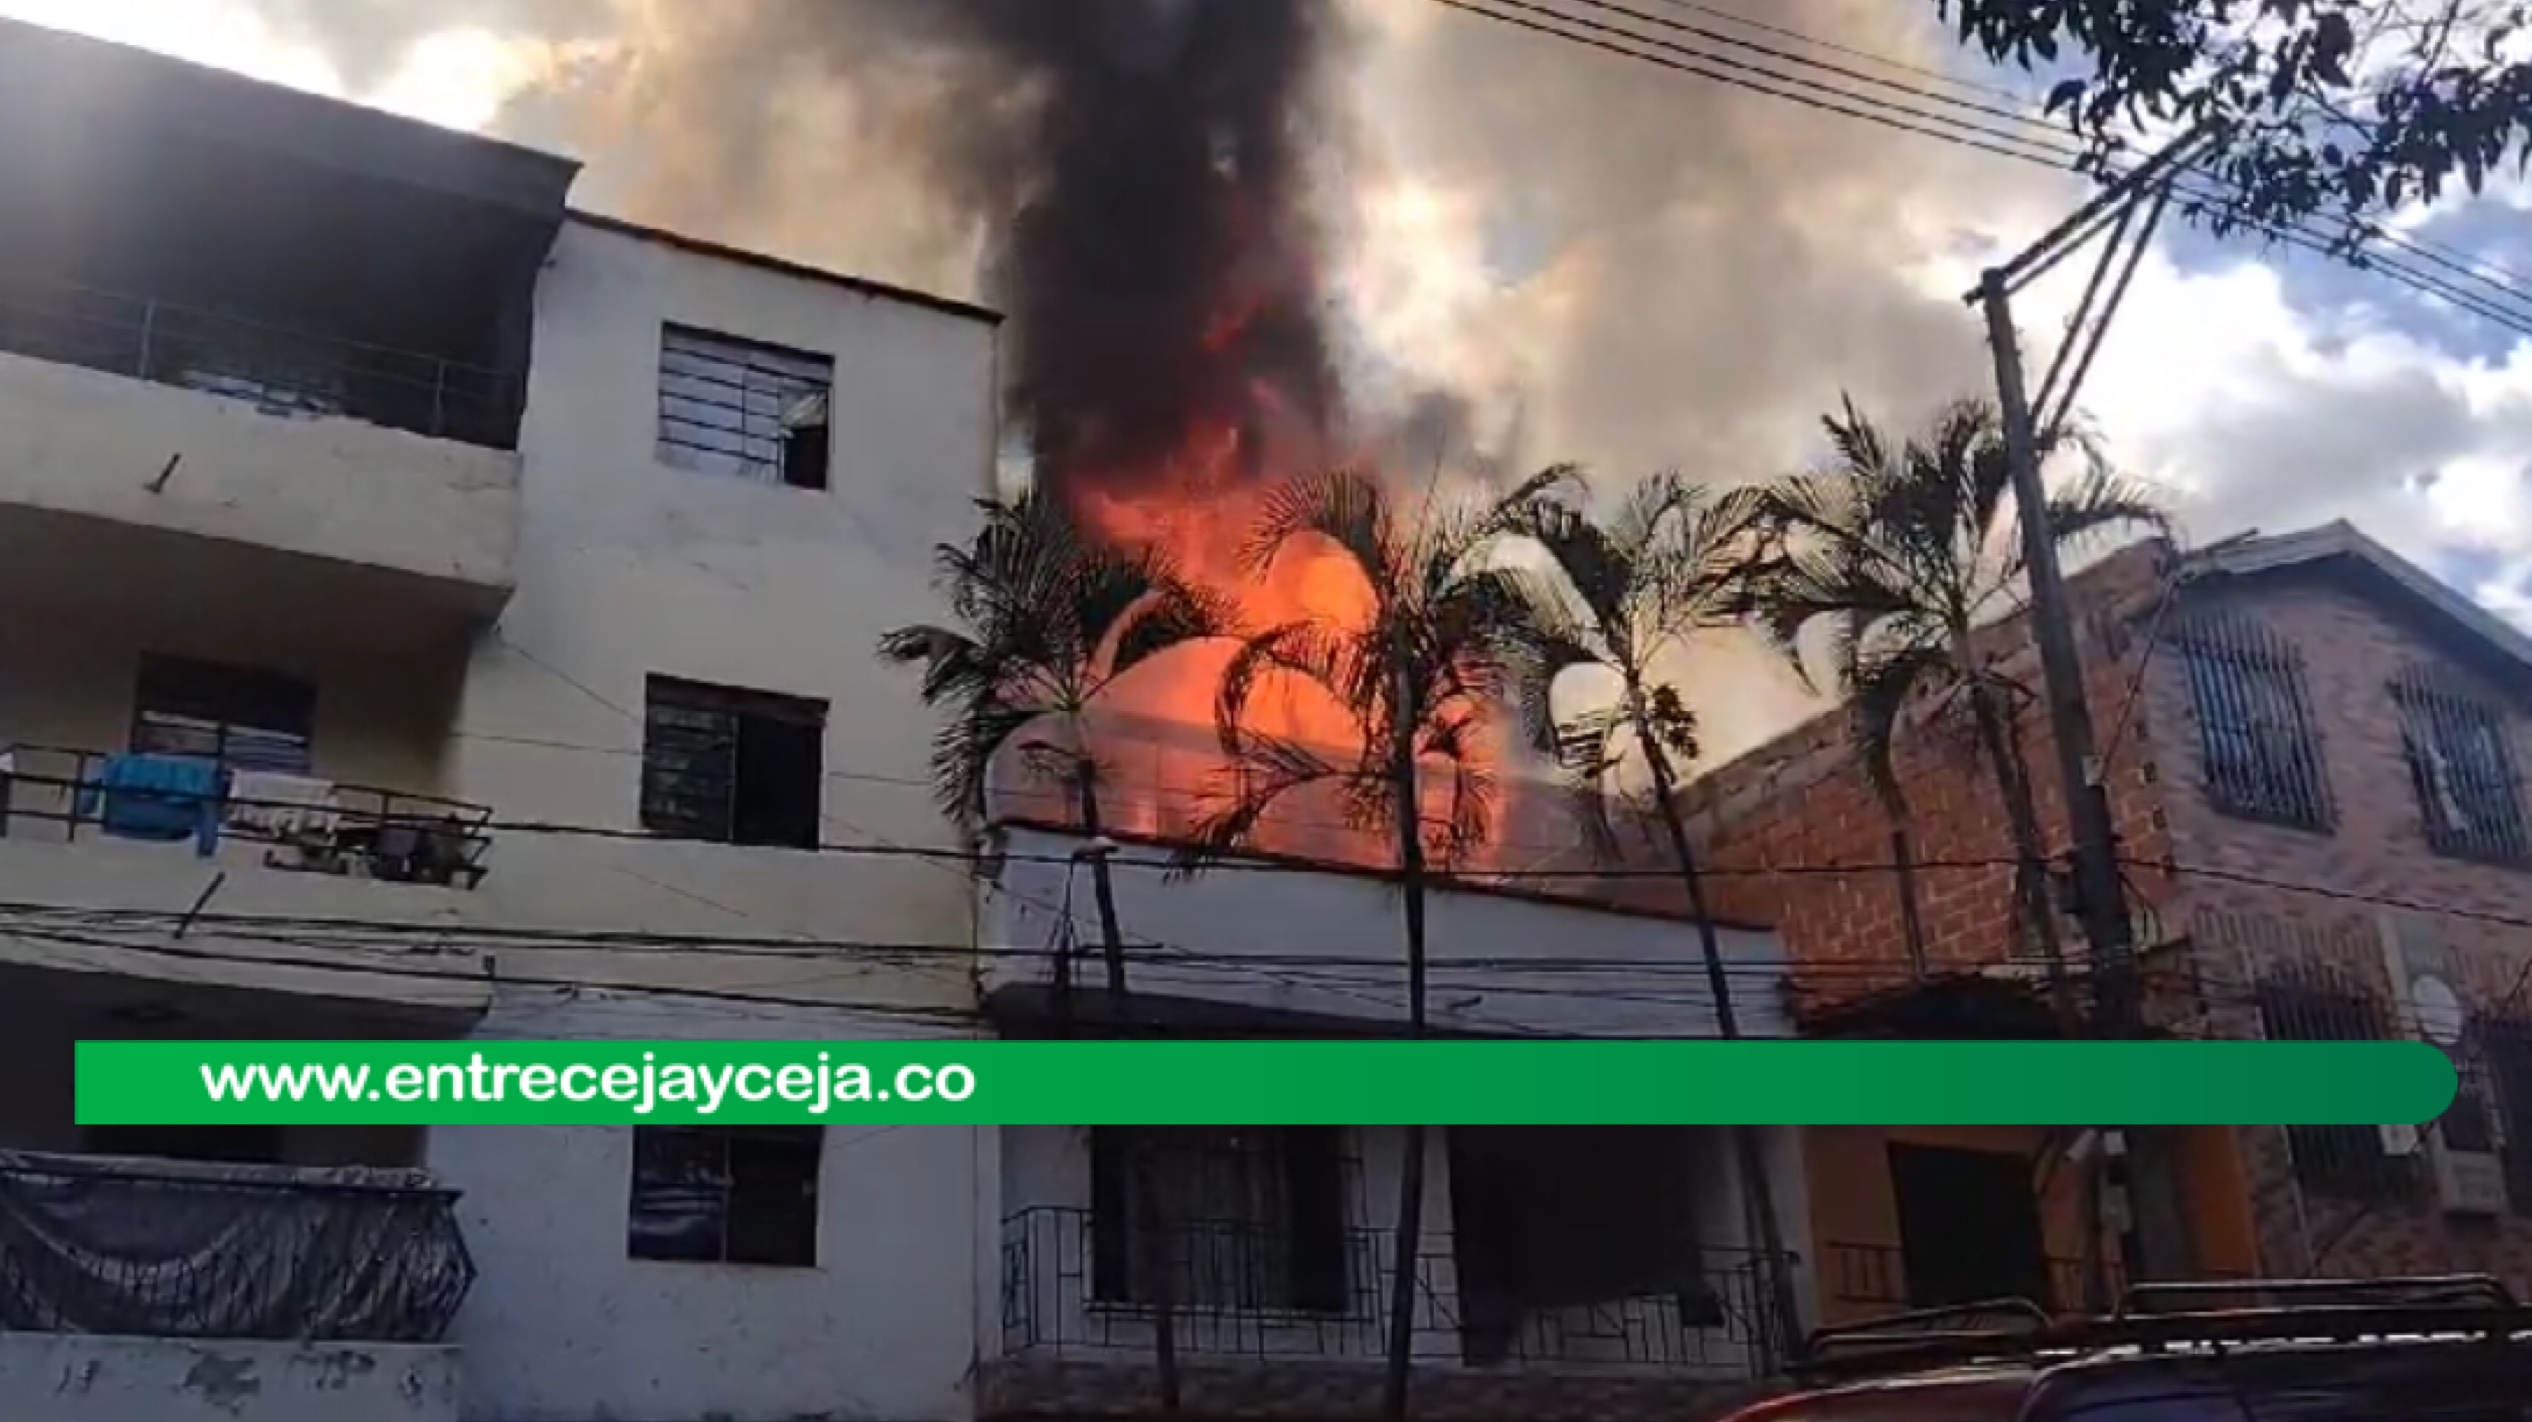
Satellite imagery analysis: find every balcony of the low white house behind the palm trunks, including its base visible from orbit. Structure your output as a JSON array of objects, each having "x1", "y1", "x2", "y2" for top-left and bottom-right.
[{"x1": 982, "y1": 1207, "x2": 1783, "y2": 1419}]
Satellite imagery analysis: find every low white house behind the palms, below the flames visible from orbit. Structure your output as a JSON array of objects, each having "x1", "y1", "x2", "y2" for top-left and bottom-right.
[{"x1": 957, "y1": 719, "x2": 1818, "y2": 1422}]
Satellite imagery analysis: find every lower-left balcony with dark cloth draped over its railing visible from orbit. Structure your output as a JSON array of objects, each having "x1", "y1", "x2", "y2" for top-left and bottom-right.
[{"x1": 0, "y1": 1151, "x2": 476, "y2": 1422}]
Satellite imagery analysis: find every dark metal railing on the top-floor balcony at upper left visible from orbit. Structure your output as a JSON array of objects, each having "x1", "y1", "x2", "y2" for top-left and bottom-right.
[{"x1": 0, "y1": 268, "x2": 522, "y2": 450}]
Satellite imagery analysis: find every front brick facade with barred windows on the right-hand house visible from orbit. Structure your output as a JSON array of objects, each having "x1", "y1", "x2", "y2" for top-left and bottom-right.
[{"x1": 2150, "y1": 569, "x2": 2532, "y2": 1293}]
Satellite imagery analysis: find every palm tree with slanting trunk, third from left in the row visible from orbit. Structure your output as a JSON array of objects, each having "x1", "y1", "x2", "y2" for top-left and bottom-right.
[{"x1": 1509, "y1": 466, "x2": 1793, "y2": 1344}]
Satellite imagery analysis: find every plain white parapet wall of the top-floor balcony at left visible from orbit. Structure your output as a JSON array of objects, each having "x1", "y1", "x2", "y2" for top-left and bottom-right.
[{"x1": 0, "y1": 354, "x2": 519, "y2": 605}]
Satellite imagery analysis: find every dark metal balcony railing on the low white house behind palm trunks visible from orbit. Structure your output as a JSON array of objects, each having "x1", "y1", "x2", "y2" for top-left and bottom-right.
[{"x1": 1003, "y1": 1207, "x2": 1793, "y2": 1379}]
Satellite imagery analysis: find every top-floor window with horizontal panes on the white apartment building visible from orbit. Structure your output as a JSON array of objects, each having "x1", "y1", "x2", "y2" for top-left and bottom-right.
[{"x1": 658, "y1": 326, "x2": 836, "y2": 488}]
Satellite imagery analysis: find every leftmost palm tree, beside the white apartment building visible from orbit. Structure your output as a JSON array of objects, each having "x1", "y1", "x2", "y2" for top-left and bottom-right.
[{"x1": 879, "y1": 478, "x2": 1231, "y2": 1414}]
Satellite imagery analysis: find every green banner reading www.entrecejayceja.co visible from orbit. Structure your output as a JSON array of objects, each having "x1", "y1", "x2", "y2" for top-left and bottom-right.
[{"x1": 76, "y1": 1040, "x2": 2456, "y2": 1126}]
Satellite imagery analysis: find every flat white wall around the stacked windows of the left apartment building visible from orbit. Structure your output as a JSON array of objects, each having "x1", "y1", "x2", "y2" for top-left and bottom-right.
[{"x1": 428, "y1": 223, "x2": 995, "y2": 1422}]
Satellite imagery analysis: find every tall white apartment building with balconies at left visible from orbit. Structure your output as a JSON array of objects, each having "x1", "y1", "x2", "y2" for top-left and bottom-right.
[{"x1": 0, "y1": 25, "x2": 998, "y2": 1422}]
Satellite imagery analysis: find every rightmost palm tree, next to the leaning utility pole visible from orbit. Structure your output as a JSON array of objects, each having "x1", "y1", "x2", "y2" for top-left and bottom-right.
[{"x1": 1750, "y1": 400, "x2": 2170, "y2": 1020}]
